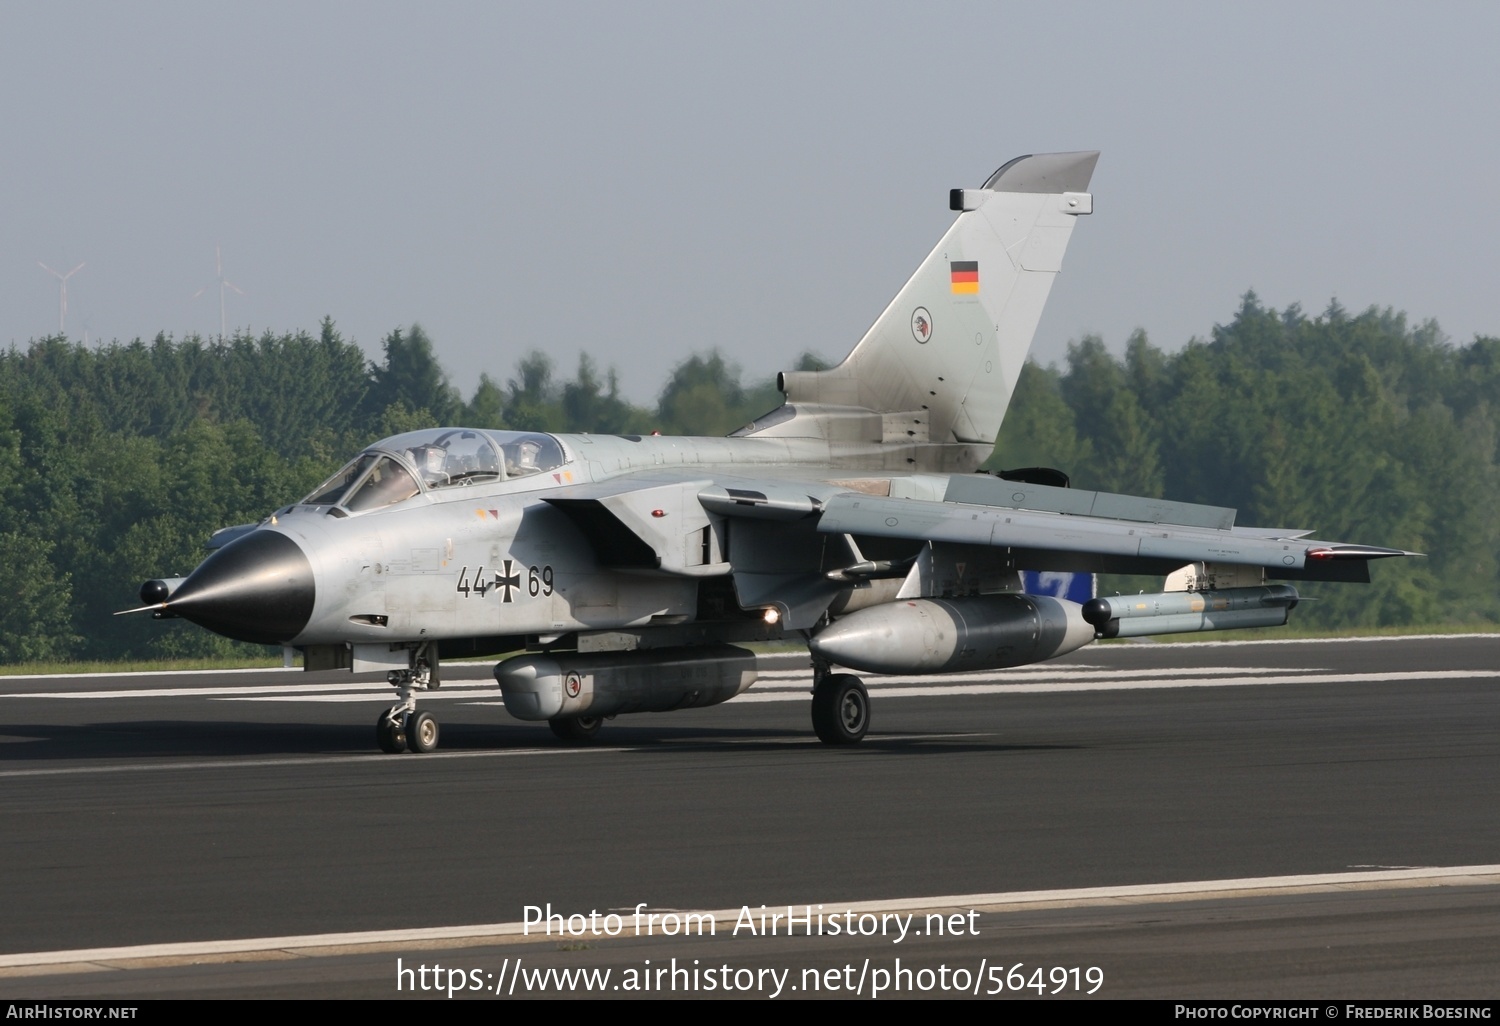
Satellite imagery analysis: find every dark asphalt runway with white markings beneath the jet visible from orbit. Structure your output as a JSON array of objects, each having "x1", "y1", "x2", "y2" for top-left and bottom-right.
[{"x1": 0, "y1": 636, "x2": 1500, "y2": 999}]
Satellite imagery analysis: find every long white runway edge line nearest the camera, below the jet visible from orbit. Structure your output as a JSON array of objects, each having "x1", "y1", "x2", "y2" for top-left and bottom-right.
[{"x1": 0, "y1": 866, "x2": 1500, "y2": 975}]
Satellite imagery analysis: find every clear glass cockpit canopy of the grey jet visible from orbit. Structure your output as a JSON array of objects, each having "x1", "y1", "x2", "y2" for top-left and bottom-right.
[{"x1": 303, "y1": 428, "x2": 567, "y2": 513}]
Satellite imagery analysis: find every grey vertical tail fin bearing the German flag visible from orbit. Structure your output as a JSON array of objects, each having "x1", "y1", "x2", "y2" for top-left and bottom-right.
[{"x1": 777, "y1": 150, "x2": 1100, "y2": 446}]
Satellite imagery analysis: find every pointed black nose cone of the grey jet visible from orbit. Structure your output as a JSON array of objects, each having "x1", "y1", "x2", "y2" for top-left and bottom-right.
[{"x1": 167, "y1": 531, "x2": 315, "y2": 645}]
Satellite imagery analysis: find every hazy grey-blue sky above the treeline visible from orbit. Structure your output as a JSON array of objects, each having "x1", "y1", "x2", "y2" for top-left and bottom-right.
[{"x1": 0, "y1": 0, "x2": 1500, "y2": 401}]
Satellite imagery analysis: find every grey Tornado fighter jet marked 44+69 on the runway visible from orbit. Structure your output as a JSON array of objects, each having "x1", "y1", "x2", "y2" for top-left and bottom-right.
[{"x1": 123, "y1": 152, "x2": 1409, "y2": 753}]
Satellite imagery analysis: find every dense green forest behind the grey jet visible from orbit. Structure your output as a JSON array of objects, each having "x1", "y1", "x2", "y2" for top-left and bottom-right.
[{"x1": 0, "y1": 294, "x2": 1500, "y2": 665}]
